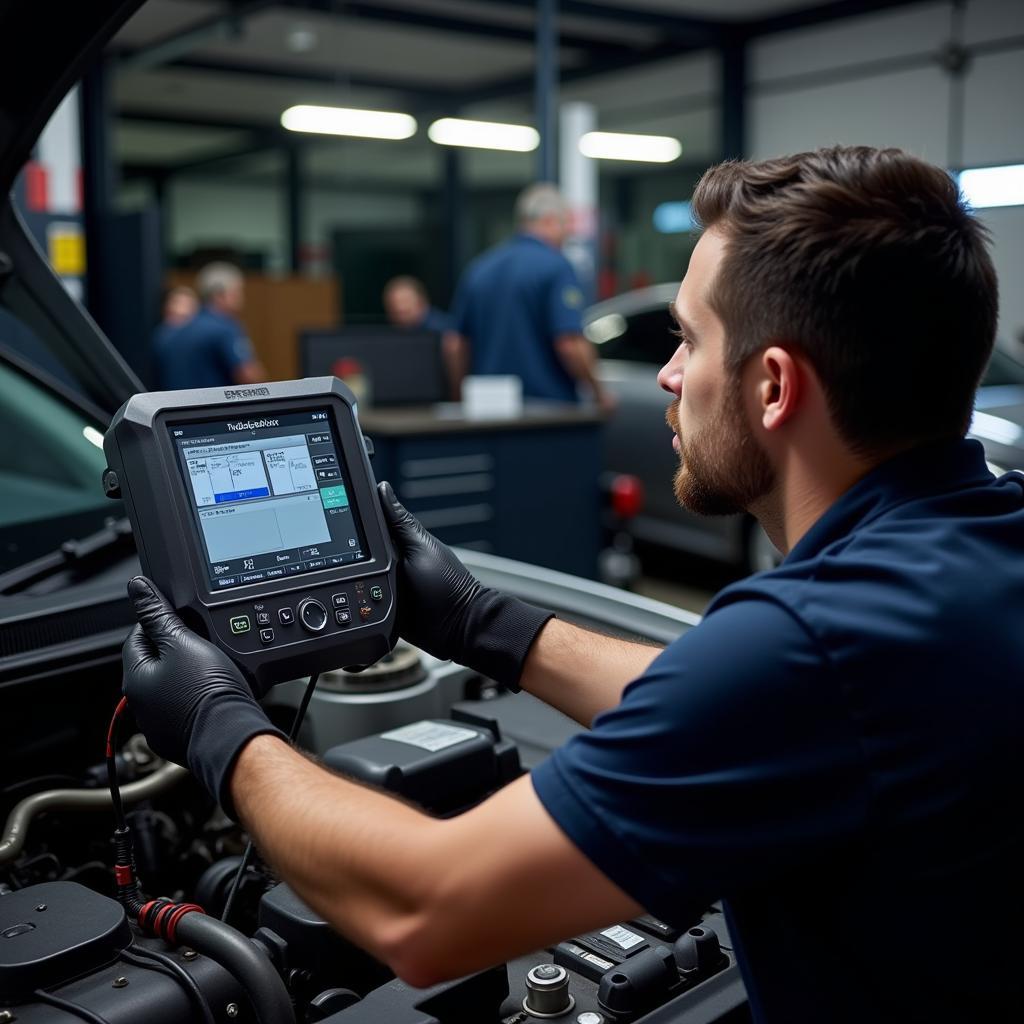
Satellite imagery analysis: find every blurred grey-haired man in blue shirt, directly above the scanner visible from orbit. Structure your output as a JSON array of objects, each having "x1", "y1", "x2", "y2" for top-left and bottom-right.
[{"x1": 154, "y1": 263, "x2": 266, "y2": 391}]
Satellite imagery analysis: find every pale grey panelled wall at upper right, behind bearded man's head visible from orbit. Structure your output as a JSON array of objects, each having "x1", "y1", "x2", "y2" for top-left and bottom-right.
[{"x1": 749, "y1": 0, "x2": 1024, "y2": 342}]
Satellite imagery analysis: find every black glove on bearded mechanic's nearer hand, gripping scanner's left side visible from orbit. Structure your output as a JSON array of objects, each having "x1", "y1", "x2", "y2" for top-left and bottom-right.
[{"x1": 122, "y1": 577, "x2": 286, "y2": 817}]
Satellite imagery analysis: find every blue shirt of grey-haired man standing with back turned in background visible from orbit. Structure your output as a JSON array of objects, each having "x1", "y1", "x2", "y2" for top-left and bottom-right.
[{"x1": 453, "y1": 233, "x2": 583, "y2": 401}]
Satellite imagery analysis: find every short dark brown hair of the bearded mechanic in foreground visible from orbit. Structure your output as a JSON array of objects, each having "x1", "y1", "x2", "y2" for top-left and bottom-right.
[{"x1": 692, "y1": 146, "x2": 998, "y2": 454}]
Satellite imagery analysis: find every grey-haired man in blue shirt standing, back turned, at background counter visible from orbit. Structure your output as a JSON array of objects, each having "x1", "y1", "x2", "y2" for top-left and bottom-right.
[{"x1": 444, "y1": 184, "x2": 611, "y2": 408}]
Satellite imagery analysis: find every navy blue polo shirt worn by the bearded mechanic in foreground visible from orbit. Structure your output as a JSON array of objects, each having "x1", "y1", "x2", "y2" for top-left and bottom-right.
[{"x1": 532, "y1": 440, "x2": 1024, "y2": 1024}]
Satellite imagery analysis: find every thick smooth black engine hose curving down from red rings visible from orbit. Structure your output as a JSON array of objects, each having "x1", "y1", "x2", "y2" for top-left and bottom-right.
[{"x1": 176, "y1": 913, "x2": 295, "y2": 1024}]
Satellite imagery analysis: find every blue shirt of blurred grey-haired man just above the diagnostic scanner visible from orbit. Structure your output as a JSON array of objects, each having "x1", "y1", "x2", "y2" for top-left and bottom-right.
[{"x1": 154, "y1": 306, "x2": 254, "y2": 391}]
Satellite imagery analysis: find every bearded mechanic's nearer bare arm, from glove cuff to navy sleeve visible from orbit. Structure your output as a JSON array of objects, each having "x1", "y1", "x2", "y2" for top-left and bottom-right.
[{"x1": 231, "y1": 736, "x2": 640, "y2": 987}]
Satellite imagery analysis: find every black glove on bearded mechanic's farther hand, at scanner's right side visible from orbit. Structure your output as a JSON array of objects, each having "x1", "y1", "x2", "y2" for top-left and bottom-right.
[{"x1": 378, "y1": 480, "x2": 553, "y2": 690}]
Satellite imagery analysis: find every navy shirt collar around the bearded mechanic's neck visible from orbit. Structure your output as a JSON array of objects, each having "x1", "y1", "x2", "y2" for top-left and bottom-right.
[{"x1": 785, "y1": 438, "x2": 992, "y2": 562}]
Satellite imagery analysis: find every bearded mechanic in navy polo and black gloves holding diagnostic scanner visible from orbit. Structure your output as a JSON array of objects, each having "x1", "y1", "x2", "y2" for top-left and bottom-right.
[{"x1": 125, "y1": 147, "x2": 1024, "y2": 1024}]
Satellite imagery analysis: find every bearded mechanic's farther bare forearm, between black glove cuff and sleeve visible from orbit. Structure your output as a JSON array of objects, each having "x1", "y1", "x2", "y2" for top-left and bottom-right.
[{"x1": 519, "y1": 618, "x2": 662, "y2": 726}]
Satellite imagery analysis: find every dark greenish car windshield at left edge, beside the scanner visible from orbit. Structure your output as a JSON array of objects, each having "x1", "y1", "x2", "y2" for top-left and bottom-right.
[{"x1": 0, "y1": 339, "x2": 121, "y2": 572}]
